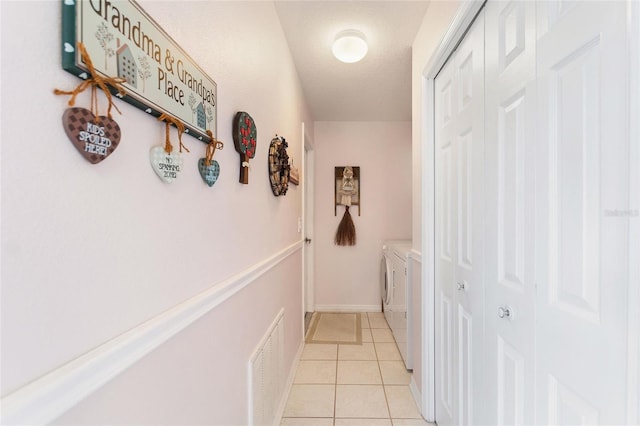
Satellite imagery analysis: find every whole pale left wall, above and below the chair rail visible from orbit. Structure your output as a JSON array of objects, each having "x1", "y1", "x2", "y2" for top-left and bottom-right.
[{"x1": 0, "y1": 0, "x2": 313, "y2": 424}]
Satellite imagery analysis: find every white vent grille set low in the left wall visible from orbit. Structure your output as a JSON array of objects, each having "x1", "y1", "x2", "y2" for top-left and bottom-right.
[{"x1": 249, "y1": 309, "x2": 284, "y2": 426}]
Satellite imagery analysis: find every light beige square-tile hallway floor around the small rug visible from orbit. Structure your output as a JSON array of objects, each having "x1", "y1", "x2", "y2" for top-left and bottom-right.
[{"x1": 280, "y1": 312, "x2": 432, "y2": 426}]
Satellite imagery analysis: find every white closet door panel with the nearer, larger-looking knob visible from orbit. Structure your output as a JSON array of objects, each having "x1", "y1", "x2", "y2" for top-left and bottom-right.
[{"x1": 482, "y1": 1, "x2": 536, "y2": 425}]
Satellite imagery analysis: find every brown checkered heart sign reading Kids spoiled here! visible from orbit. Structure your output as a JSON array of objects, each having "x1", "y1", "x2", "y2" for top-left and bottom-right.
[{"x1": 62, "y1": 107, "x2": 121, "y2": 164}]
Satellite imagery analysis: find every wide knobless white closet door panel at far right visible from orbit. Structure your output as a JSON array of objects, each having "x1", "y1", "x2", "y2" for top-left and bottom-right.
[{"x1": 535, "y1": 1, "x2": 639, "y2": 425}]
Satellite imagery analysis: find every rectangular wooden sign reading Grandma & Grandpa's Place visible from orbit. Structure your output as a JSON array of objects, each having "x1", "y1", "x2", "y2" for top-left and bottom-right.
[{"x1": 62, "y1": 0, "x2": 217, "y2": 143}]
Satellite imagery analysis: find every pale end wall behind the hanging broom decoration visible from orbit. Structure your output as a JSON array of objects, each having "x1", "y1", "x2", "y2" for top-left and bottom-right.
[{"x1": 314, "y1": 122, "x2": 411, "y2": 310}]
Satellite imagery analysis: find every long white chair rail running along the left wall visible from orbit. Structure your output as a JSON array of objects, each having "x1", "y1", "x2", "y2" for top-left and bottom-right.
[{"x1": 1, "y1": 241, "x2": 302, "y2": 424}]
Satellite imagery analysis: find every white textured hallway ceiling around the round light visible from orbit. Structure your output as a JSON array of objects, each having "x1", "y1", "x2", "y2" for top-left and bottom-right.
[{"x1": 275, "y1": 0, "x2": 429, "y2": 121}]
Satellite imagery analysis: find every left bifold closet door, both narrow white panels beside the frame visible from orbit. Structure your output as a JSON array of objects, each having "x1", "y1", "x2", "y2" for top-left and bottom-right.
[{"x1": 435, "y1": 9, "x2": 484, "y2": 426}]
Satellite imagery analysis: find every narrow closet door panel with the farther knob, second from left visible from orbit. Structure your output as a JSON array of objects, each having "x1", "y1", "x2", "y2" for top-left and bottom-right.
[{"x1": 455, "y1": 12, "x2": 485, "y2": 425}]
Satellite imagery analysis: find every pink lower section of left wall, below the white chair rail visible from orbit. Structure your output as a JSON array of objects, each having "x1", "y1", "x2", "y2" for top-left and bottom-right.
[{"x1": 55, "y1": 252, "x2": 301, "y2": 426}]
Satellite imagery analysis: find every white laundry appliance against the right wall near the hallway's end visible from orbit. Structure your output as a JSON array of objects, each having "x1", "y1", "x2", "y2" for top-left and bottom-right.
[{"x1": 380, "y1": 240, "x2": 413, "y2": 370}]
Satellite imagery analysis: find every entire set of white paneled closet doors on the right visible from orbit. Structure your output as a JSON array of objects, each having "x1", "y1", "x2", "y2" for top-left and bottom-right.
[{"x1": 434, "y1": 1, "x2": 640, "y2": 426}]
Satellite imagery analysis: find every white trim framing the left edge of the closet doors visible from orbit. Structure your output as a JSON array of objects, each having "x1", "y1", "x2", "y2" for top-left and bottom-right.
[{"x1": 420, "y1": 0, "x2": 485, "y2": 422}]
